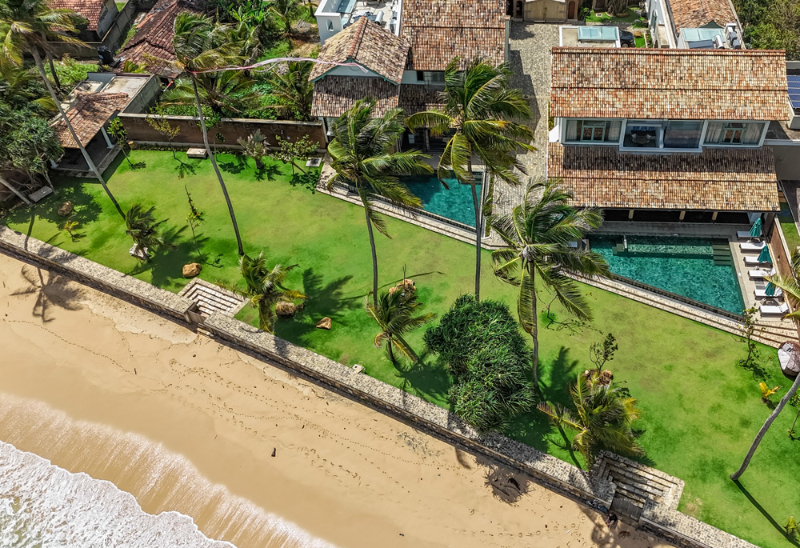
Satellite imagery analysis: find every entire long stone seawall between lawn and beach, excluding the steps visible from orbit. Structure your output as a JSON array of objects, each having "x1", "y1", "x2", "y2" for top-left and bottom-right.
[{"x1": 0, "y1": 226, "x2": 758, "y2": 548}]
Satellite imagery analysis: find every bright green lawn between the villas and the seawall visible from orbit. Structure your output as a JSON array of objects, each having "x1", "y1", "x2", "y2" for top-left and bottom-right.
[{"x1": 5, "y1": 151, "x2": 800, "y2": 548}]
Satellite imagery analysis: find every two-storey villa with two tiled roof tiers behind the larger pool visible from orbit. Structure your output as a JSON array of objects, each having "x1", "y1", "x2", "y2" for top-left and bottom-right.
[{"x1": 547, "y1": 48, "x2": 789, "y2": 223}]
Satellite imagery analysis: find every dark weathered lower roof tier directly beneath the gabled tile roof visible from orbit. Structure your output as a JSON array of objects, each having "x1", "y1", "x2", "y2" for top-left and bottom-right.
[{"x1": 311, "y1": 76, "x2": 400, "y2": 117}]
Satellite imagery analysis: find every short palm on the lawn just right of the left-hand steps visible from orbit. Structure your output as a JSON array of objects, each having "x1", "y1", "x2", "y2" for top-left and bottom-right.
[{"x1": 234, "y1": 252, "x2": 305, "y2": 333}]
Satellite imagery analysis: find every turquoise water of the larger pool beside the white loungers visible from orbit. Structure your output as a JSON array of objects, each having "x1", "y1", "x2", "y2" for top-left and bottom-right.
[{"x1": 590, "y1": 236, "x2": 744, "y2": 314}]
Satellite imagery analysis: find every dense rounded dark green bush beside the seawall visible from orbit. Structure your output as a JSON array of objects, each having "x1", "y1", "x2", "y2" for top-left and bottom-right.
[{"x1": 425, "y1": 295, "x2": 536, "y2": 432}]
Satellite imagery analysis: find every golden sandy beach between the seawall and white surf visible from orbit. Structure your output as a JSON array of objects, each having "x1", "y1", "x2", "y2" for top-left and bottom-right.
[{"x1": 0, "y1": 255, "x2": 669, "y2": 548}]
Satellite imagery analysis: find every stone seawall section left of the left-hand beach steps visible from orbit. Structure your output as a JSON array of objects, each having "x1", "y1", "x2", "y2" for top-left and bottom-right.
[{"x1": 0, "y1": 226, "x2": 197, "y2": 324}]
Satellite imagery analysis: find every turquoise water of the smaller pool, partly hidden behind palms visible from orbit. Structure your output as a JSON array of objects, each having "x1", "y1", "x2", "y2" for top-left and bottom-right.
[{"x1": 401, "y1": 174, "x2": 481, "y2": 227}]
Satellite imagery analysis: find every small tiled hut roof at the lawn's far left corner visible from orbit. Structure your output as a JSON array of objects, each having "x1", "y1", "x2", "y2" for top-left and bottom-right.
[{"x1": 53, "y1": 93, "x2": 130, "y2": 148}]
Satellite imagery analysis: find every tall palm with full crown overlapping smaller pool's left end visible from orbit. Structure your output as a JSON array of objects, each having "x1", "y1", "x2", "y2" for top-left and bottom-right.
[{"x1": 327, "y1": 99, "x2": 433, "y2": 308}]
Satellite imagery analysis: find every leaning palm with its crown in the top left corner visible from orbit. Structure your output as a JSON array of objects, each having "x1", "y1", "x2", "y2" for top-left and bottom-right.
[{"x1": 0, "y1": 0, "x2": 125, "y2": 218}]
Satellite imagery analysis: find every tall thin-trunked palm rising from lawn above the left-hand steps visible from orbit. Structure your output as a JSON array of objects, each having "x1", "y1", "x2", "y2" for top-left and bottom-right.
[{"x1": 173, "y1": 12, "x2": 244, "y2": 257}]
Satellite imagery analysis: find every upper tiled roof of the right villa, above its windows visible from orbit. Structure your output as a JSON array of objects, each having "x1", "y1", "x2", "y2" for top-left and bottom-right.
[{"x1": 550, "y1": 48, "x2": 789, "y2": 120}]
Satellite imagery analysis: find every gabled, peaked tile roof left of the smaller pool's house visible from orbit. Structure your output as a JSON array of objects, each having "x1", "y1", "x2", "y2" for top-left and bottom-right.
[{"x1": 311, "y1": 17, "x2": 408, "y2": 84}]
